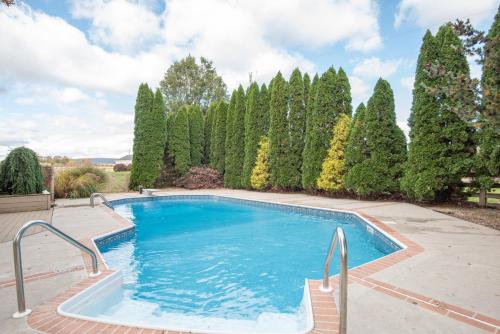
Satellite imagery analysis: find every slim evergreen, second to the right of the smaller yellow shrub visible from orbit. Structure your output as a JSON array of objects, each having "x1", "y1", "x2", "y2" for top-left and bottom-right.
[{"x1": 288, "y1": 68, "x2": 306, "y2": 189}]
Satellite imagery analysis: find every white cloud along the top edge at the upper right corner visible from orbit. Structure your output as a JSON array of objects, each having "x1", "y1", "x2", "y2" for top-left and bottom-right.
[{"x1": 394, "y1": 0, "x2": 498, "y2": 30}]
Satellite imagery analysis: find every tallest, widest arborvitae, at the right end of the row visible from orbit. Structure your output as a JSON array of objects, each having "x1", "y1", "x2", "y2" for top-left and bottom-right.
[{"x1": 401, "y1": 25, "x2": 474, "y2": 200}]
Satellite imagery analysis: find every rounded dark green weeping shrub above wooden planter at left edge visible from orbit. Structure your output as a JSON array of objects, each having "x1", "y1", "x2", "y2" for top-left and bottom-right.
[{"x1": 0, "y1": 147, "x2": 45, "y2": 195}]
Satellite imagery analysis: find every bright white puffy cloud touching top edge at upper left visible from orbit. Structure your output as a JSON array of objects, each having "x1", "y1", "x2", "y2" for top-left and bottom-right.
[{"x1": 71, "y1": 0, "x2": 161, "y2": 52}]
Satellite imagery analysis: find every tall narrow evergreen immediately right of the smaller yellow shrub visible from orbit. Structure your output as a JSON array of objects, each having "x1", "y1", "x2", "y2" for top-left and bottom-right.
[{"x1": 269, "y1": 72, "x2": 291, "y2": 188}]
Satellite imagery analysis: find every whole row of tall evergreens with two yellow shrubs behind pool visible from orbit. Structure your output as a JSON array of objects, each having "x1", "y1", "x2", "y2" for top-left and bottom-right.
[{"x1": 130, "y1": 17, "x2": 498, "y2": 200}]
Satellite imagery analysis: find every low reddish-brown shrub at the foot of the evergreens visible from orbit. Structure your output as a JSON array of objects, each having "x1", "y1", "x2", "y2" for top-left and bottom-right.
[{"x1": 174, "y1": 167, "x2": 224, "y2": 189}]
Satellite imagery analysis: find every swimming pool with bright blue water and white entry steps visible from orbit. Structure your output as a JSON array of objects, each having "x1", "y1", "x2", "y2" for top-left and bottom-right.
[{"x1": 57, "y1": 196, "x2": 401, "y2": 333}]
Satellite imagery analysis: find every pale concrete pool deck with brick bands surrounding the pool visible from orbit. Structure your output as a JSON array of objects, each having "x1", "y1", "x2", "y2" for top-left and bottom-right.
[{"x1": 0, "y1": 189, "x2": 500, "y2": 334}]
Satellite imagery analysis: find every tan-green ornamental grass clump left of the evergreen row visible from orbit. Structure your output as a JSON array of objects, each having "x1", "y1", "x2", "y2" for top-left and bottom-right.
[{"x1": 55, "y1": 167, "x2": 106, "y2": 198}]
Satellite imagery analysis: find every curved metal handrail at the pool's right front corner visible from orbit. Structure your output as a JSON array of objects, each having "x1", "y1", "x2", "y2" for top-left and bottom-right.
[{"x1": 320, "y1": 226, "x2": 348, "y2": 334}]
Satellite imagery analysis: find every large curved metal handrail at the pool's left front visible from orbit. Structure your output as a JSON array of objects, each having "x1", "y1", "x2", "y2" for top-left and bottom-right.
[{"x1": 12, "y1": 220, "x2": 100, "y2": 318}]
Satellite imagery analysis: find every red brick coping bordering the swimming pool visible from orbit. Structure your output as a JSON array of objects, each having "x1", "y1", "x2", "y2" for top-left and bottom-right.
[{"x1": 28, "y1": 195, "x2": 500, "y2": 334}]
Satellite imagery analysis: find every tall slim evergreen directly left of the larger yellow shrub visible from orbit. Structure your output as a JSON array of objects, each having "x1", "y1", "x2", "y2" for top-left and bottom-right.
[{"x1": 302, "y1": 68, "x2": 337, "y2": 189}]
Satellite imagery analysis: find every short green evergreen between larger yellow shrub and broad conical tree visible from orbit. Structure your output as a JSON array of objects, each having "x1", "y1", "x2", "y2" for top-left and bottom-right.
[{"x1": 345, "y1": 103, "x2": 370, "y2": 171}]
